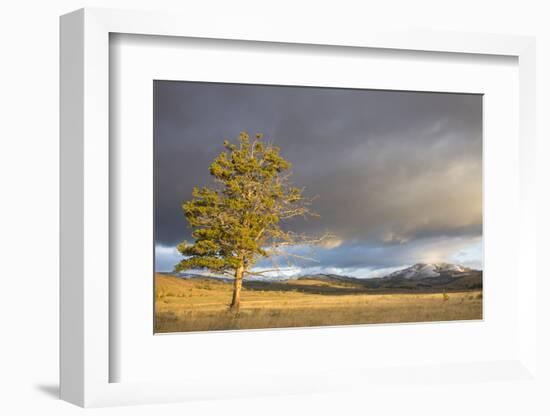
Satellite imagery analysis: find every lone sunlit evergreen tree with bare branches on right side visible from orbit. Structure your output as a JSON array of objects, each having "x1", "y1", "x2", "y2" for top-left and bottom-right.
[{"x1": 175, "y1": 132, "x2": 329, "y2": 312}]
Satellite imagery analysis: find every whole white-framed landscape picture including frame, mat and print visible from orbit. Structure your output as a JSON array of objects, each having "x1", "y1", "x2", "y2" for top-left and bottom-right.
[{"x1": 61, "y1": 9, "x2": 539, "y2": 406}]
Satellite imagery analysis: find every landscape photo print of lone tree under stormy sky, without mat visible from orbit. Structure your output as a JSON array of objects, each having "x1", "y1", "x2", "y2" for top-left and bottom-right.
[{"x1": 154, "y1": 80, "x2": 483, "y2": 333}]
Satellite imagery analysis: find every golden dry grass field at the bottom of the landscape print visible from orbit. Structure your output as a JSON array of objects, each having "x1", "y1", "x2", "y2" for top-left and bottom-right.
[{"x1": 155, "y1": 274, "x2": 483, "y2": 333}]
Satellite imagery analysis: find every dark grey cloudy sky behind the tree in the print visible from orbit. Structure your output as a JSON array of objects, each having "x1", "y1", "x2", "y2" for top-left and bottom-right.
[{"x1": 155, "y1": 81, "x2": 482, "y2": 277}]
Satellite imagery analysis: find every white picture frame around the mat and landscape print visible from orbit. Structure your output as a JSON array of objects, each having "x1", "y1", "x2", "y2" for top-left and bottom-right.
[{"x1": 60, "y1": 9, "x2": 539, "y2": 407}]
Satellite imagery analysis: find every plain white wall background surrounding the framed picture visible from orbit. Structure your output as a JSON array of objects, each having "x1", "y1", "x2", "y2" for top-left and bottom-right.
[{"x1": 0, "y1": 0, "x2": 550, "y2": 415}]
